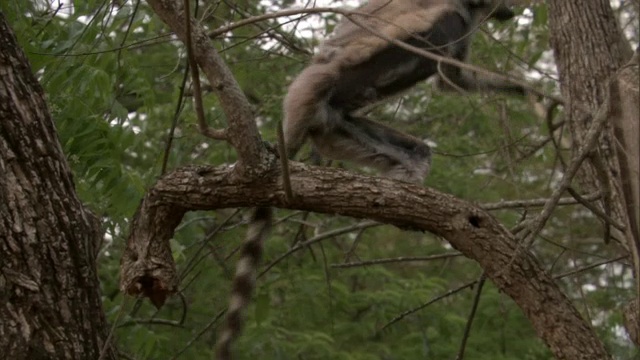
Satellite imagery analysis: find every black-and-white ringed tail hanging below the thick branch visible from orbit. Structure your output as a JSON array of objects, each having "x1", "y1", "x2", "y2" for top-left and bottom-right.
[{"x1": 216, "y1": 207, "x2": 273, "y2": 360}]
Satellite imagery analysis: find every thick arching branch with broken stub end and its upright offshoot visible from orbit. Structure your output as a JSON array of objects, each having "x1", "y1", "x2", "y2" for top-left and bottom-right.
[{"x1": 120, "y1": 0, "x2": 610, "y2": 360}]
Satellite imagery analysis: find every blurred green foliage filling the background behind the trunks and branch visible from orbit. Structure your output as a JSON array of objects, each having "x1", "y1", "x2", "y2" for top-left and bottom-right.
[{"x1": 0, "y1": 0, "x2": 638, "y2": 360}]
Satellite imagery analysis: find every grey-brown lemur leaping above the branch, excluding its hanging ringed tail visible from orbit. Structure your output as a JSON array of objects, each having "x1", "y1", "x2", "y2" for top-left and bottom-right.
[{"x1": 283, "y1": 0, "x2": 525, "y2": 183}]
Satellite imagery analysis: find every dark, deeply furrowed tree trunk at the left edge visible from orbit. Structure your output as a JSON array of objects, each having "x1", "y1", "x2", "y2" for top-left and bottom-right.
[{"x1": 0, "y1": 12, "x2": 116, "y2": 360}]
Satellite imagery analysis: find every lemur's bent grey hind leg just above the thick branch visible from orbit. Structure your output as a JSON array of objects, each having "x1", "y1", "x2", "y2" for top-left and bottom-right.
[{"x1": 310, "y1": 115, "x2": 431, "y2": 183}]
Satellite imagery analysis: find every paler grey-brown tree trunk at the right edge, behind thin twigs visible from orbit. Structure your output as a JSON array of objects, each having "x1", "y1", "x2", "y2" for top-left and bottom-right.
[{"x1": 549, "y1": 0, "x2": 640, "y2": 345}]
